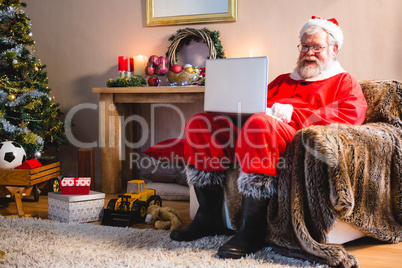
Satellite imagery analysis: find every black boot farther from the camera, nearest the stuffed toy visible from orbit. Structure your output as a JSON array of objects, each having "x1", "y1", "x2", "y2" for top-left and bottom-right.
[{"x1": 170, "y1": 184, "x2": 225, "y2": 241}]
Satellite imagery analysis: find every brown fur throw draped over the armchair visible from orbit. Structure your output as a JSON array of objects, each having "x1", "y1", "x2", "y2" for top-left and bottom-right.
[{"x1": 225, "y1": 81, "x2": 402, "y2": 267}]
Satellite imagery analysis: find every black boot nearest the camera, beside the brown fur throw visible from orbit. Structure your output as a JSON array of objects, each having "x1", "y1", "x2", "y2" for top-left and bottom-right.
[{"x1": 218, "y1": 196, "x2": 268, "y2": 259}]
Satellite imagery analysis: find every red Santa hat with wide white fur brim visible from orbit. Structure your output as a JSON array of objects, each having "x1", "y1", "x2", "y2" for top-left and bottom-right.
[{"x1": 300, "y1": 16, "x2": 343, "y2": 49}]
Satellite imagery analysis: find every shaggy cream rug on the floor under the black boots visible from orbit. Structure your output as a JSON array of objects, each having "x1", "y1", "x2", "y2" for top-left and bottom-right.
[{"x1": 0, "y1": 216, "x2": 326, "y2": 268}]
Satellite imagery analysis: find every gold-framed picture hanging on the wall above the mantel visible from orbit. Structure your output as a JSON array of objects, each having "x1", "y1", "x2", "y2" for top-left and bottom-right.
[{"x1": 146, "y1": 0, "x2": 237, "y2": 26}]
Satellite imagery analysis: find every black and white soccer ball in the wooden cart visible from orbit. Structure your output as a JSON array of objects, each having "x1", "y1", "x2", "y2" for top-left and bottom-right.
[{"x1": 0, "y1": 141, "x2": 26, "y2": 169}]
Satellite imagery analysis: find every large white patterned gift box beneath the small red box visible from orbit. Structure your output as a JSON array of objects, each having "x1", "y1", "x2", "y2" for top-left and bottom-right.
[{"x1": 48, "y1": 191, "x2": 105, "y2": 223}]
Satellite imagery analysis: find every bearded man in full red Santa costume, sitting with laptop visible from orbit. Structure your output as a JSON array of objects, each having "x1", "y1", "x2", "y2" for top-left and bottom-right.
[{"x1": 170, "y1": 16, "x2": 367, "y2": 258}]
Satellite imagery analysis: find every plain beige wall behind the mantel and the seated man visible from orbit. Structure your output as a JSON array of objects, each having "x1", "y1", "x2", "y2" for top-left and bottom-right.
[{"x1": 25, "y1": 0, "x2": 402, "y2": 192}]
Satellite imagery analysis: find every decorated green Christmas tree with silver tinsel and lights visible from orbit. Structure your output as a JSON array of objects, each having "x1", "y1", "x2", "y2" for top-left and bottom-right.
[{"x1": 0, "y1": 0, "x2": 66, "y2": 159}]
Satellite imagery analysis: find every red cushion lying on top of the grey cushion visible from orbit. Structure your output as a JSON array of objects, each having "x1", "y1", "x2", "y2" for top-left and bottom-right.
[{"x1": 144, "y1": 139, "x2": 184, "y2": 162}]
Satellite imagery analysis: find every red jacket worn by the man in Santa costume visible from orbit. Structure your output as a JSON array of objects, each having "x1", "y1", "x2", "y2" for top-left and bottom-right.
[{"x1": 267, "y1": 67, "x2": 367, "y2": 129}]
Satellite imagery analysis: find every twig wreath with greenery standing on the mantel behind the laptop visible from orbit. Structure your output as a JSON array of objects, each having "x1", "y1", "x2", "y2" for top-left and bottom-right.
[{"x1": 166, "y1": 28, "x2": 225, "y2": 65}]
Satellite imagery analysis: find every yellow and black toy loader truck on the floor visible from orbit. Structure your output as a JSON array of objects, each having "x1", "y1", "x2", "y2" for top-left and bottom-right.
[{"x1": 102, "y1": 180, "x2": 162, "y2": 226}]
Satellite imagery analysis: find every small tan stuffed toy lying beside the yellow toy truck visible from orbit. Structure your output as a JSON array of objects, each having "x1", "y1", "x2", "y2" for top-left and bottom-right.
[{"x1": 145, "y1": 201, "x2": 182, "y2": 231}]
